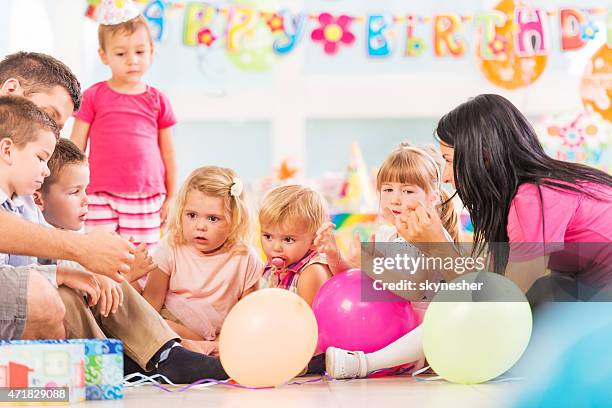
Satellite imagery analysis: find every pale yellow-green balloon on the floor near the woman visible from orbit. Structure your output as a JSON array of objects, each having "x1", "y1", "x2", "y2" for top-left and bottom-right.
[{"x1": 423, "y1": 272, "x2": 532, "y2": 384}]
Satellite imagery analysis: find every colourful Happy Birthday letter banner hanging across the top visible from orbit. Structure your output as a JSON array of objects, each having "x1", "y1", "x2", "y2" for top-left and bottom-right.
[{"x1": 86, "y1": 0, "x2": 612, "y2": 90}]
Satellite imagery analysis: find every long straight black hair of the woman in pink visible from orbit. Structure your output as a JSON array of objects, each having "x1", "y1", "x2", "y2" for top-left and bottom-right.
[{"x1": 436, "y1": 94, "x2": 612, "y2": 273}]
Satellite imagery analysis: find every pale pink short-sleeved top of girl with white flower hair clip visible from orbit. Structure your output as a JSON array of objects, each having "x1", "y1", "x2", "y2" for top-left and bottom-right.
[{"x1": 151, "y1": 237, "x2": 263, "y2": 340}]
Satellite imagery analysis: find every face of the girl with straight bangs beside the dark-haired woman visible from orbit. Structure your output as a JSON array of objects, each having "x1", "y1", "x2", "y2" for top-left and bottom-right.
[{"x1": 380, "y1": 183, "x2": 438, "y2": 223}]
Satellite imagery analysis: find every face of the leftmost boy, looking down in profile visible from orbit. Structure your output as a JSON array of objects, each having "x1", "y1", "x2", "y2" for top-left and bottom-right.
[{"x1": 0, "y1": 130, "x2": 55, "y2": 197}]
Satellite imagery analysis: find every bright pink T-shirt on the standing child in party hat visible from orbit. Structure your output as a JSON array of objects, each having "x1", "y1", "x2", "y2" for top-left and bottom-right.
[{"x1": 75, "y1": 81, "x2": 176, "y2": 193}]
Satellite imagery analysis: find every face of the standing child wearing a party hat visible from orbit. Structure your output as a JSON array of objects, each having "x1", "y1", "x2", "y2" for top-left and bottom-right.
[{"x1": 99, "y1": 28, "x2": 153, "y2": 84}]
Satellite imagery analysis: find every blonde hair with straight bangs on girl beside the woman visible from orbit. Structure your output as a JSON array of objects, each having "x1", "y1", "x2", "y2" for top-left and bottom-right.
[{"x1": 376, "y1": 142, "x2": 461, "y2": 242}]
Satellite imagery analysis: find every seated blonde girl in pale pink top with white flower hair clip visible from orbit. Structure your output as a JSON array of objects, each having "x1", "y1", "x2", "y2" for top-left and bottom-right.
[{"x1": 143, "y1": 166, "x2": 263, "y2": 354}]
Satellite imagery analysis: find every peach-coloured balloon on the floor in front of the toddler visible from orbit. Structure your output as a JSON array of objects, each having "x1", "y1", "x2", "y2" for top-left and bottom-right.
[{"x1": 219, "y1": 289, "x2": 317, "y2": 387}]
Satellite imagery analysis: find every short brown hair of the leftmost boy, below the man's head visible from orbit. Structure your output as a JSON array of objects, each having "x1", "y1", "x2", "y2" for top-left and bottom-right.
[{"x1": 0, "y1": 96, "x2": 59, "y2": 148}]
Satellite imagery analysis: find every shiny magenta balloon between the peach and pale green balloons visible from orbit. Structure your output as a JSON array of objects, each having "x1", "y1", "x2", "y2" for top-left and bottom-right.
[{"x1": 312, "y1": 269, "x2": 419, "y2": 353}]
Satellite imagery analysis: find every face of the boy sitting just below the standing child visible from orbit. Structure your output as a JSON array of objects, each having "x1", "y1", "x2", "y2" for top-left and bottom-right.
[{"x1": 40, "y1": 163, "x2": 89, "y2": 231}]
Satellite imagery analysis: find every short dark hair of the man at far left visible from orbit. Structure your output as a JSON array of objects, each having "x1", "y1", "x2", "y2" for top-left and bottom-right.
[{"x1": 0, "y1": 51, "x2": 81, "y2": 110}]
